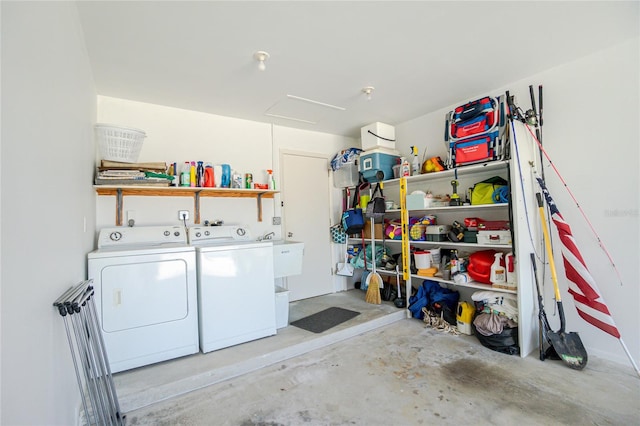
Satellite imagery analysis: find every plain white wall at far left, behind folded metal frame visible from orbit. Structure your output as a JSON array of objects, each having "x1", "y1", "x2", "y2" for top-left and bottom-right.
[{"x1": 0, "y1": 2, "x2": 96, "y2": 425}]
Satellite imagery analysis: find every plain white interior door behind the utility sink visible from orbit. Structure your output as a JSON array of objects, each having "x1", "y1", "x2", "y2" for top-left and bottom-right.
[{"x1": 281, "y1": 153, "x2": 334, "y2": 301}]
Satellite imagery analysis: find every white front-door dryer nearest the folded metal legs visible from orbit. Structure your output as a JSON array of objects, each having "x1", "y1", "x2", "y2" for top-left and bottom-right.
[{"x1": 87, "y1": 226, "x2": 199, "y2": 373}]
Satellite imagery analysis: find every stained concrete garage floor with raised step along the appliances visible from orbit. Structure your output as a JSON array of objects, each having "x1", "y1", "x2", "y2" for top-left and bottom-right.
[{"x1": 114, "y1": 290, "x2": 640, "y2": 425}]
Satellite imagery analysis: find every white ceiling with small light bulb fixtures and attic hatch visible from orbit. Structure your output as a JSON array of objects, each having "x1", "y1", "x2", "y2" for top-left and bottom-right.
[{"x1": 78, "y1": 1, "x2": 639, "y2": 137}]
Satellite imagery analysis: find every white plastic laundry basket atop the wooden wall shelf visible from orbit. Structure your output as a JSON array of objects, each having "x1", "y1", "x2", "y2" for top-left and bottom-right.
[{"x1": 95, "y1": 124, "x2": 147, "y2": 163}]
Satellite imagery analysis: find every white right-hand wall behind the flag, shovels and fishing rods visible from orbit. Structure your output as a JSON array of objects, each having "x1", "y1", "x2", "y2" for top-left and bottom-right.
[{"x1": 396, "y1": 38, "x2": 640, "y2": 363}]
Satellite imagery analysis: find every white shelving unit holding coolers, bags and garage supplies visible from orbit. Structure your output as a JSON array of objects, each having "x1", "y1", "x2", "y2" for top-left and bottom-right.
[{"x1": 352, "y1": 159, "x2": 538, "y2": 357}]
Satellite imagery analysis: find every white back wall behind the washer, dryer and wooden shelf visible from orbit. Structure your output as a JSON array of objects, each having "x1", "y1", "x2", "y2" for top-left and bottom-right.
[{"x1": 96, "y1": 96, "x2": 354, "y2": 243}]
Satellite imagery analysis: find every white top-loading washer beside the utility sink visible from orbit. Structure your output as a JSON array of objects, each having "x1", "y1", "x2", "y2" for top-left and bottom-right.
[{"x1": 189, "y1": 225, "x2": 276, "y2": 353}]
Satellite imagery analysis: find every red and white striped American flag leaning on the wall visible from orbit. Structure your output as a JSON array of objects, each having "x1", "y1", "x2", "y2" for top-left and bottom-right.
[{"x1": 536, "y1": 177, "x2": 620, "y2": 339}]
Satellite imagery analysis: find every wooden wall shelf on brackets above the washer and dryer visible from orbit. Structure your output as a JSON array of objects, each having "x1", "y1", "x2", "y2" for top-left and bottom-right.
[{"x1": 93, "y1": 185, "x2": 279, "y2": 226}]
